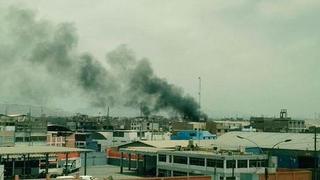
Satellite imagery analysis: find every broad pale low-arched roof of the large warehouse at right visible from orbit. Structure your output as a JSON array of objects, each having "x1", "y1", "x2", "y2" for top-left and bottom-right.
[{"x1": 214, "y1": 131, "x2": 320, "y2": 151}]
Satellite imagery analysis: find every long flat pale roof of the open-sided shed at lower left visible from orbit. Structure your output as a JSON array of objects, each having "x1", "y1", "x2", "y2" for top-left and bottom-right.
[{"x1": 0, "y1": 146, "x2": 92, "y2": 155}]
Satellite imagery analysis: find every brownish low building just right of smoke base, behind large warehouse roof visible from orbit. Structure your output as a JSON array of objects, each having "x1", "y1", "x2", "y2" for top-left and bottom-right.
[{"x1": 206, "y1": 120, "x2": 250, "y2": 136}]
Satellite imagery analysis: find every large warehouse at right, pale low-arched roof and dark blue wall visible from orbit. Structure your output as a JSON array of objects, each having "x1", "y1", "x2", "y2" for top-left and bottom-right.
[{"x1": 212, "y1": 131, "x2": 320, "y2": 173}]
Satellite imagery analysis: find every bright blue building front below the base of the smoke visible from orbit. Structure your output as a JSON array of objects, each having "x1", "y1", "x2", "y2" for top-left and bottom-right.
[{"x1": 171, "y1": 130, "x2": 217, "y2": 140}]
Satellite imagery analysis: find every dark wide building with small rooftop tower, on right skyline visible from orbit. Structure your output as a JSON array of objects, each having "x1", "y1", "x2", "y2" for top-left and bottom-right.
[{"x1": 250, "y1": 110, "x2": 306, "y2": 133}]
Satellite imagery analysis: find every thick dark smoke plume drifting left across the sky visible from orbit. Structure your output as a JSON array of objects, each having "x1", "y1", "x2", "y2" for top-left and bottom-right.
[{"x1": 0, "y1": 7, "x2": 205, "y2": 120}]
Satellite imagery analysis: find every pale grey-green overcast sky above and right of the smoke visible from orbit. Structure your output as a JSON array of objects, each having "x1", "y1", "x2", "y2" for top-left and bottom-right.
[{"x1": 0, "y1": 0, "x2": 320, "y2": 117}]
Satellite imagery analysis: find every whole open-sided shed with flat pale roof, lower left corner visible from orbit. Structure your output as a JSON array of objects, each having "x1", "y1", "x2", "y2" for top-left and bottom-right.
[{"x1": 0, "y1": 146, "x2": 91, "y2": 178}]
